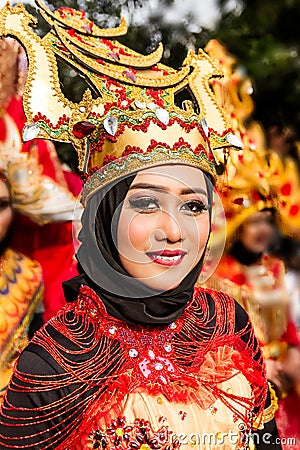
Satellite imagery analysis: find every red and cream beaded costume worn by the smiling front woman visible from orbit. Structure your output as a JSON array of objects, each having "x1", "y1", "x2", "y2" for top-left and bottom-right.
[{"x1": 0, "y1": 286, "x2": 266, "y2": 450}]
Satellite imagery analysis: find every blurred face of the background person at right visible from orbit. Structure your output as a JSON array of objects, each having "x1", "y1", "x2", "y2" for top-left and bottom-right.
[{"x1": 240, "y1": 211, "x2": 274, "y2": 253}]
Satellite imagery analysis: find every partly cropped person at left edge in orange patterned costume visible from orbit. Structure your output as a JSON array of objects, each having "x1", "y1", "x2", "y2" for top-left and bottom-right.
[{"x1": 0, "y1": 173, "x2": 43, "y2": 398}]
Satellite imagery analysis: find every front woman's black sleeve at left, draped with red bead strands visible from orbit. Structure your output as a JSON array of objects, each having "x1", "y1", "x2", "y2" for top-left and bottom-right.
[{"x1": 0, "y1": 317, "x2": 105, "y2": 450}]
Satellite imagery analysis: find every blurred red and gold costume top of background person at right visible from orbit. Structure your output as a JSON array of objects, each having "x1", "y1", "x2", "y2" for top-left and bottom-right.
[{"x1": 210, "y1": 254, "x2": 299, "y2": 359}]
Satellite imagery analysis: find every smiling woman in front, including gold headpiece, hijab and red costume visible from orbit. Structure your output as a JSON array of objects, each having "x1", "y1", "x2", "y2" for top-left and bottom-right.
[{"x1": 0, "y1": 5, "x2": 280, "y2": 450}]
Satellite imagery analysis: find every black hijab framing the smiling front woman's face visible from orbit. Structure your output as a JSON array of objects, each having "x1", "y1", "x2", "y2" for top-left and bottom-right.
[{"x1": 64, "y1": 169, "x2": 212, "y2": 325}]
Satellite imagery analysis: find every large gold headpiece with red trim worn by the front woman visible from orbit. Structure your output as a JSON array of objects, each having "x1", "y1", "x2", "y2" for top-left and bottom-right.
[{"x1": 0, "y1": 0, "x2": 240, "y2": 204}]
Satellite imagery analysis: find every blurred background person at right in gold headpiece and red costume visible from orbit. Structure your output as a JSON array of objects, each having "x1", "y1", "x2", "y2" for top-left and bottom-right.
[{"x1": 206, "y1": 40, "x2": 300, "y2": 450}]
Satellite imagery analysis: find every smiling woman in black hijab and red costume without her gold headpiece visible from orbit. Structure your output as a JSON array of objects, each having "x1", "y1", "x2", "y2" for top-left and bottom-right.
[{"x1": 0, "y1": 164, "x2": 282, "y2": 449}]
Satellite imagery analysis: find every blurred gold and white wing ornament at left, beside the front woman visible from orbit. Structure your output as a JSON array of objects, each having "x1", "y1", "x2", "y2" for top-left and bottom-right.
[{"x1": 0, "y1": 38, "x2": 82, "y2": 224}]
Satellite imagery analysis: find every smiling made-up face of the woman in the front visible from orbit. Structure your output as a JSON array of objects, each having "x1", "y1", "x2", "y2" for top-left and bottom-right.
[{"x1": 118, "y1": 165, "x2": 210, "y2": 290}]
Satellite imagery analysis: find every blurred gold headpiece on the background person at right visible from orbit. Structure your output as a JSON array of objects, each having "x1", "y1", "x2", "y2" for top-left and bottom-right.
[{"x1": 205, "y1": 40, "x2": 300, "y2": 241}]
